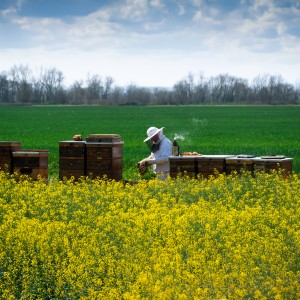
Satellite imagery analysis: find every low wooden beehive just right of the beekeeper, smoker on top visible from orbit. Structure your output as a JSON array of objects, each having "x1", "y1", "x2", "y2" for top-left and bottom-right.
[{"x1": 169, "y1": 156, "x2": 198, "y2": 178}]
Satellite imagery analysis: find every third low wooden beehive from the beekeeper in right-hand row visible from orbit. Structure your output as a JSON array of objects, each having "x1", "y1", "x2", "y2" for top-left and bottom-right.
[{"x1": 225, "y1": 155, "x2": 254, "y2": 174}]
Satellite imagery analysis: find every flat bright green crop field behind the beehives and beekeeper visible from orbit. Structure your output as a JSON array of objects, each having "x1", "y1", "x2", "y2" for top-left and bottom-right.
[{"x1": 0, "y1": 106, "x2": 300, "y2": 179}]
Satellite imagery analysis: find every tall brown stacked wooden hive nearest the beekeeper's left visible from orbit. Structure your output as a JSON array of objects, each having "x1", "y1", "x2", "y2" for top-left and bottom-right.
[{"x1": 86, "y1": 134, "x2": 124, "y2": 180}]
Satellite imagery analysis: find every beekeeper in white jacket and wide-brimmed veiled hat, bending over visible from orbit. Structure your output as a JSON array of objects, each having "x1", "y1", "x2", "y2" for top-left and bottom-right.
[{"x1": 138, "y1": 127, "x2": 172, "y2": 180}]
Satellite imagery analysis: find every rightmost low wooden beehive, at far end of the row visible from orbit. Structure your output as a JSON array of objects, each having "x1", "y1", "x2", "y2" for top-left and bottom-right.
[{"x1": 253, "y1": 155, "x2": 293, "y2": 175}]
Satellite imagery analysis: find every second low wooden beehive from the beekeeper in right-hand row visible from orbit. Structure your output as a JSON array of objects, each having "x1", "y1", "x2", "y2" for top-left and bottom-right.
[{"x1": 197, "y1": 155, "x2": 233, "y2": 178}]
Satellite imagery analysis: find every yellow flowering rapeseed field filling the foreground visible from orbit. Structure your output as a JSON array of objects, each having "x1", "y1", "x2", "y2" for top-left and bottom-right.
[{"x1": 0, "y1": 172, "x2": 300, "y2": 299}]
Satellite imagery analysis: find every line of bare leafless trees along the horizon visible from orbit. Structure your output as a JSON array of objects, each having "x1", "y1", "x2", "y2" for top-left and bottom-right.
[{"x1": 0, "y1": 65, "x2": 300, "y2": 105}]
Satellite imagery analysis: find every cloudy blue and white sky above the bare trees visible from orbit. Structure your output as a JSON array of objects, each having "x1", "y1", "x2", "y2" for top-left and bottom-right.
[{"x1": 0, "y1": 0, "x2": 300, "y2": 87}]
